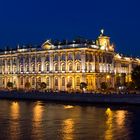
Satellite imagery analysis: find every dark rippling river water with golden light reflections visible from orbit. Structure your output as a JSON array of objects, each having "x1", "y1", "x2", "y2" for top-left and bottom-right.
[{"x1": 0, "y1": 100, "x2": 140, "y2": 140}]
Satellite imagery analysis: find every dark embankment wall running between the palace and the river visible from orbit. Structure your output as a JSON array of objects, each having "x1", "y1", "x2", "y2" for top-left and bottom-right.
[{"x1": 0, "y1": 91, "x2": 140, "y2": 105}]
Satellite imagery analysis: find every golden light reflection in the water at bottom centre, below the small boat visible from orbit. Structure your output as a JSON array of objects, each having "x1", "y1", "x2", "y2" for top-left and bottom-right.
[{"x1": 62, "y1": 119, "x2": 74, "y2": 140}]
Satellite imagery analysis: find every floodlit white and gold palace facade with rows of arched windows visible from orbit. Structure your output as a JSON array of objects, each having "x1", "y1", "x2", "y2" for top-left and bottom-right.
[{"x1": 0, "y1": 30, "x2": 140, "y2": 91}]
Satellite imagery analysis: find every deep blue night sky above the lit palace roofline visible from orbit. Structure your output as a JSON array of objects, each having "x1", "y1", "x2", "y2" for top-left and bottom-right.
[{"x1": 0, "y1": 0, "x2": 140, "y2": 56}]
